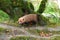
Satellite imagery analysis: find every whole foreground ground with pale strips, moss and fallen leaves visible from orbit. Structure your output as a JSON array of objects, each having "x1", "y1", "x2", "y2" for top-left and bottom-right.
[{"x1": 0, "y1": 24, "x2": 60, "y2": 40}]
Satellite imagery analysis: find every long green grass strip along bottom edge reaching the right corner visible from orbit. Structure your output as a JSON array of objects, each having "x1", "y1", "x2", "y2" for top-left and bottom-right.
[{"x1": 10, "y1": 36, "x2": 60, "y2": 40}]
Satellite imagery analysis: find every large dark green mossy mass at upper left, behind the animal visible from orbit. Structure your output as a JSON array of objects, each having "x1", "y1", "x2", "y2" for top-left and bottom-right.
[{"x1": 0, "y1": 0, "x2": 34, "y2": 21}]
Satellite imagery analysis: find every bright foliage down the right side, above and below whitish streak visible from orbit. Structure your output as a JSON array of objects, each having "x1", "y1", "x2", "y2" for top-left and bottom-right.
[{"x1": 44, "y1": 1, "x2": 60, "y2": 24}]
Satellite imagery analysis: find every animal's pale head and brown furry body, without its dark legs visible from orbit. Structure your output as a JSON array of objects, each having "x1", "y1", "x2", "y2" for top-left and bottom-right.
[{"x1": 18, "y1": 14, "x2": 38, "y2": 24}]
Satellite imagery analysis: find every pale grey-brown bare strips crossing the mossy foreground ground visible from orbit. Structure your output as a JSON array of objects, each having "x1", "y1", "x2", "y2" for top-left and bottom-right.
[{"x1": 0, "y1": 24, "x2": 60, "y2": 40}]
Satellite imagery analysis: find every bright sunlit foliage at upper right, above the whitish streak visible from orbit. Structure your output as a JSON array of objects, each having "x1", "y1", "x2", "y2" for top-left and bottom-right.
[{"x1": 44, "y1": 1, "x2": 59, "y2": 13}]
